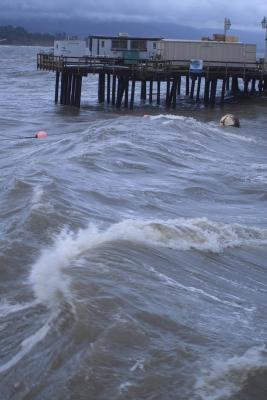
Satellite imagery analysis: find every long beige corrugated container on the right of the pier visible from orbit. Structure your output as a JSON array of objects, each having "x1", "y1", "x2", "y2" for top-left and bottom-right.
[{"x1": 157, "y1": 39, "x2": 256, "y2": 65}]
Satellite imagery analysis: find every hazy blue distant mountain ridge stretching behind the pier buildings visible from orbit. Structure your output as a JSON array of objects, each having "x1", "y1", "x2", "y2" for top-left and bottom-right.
[{"x1": 0, "y1": 19, "x2": 264, "y2": 53}]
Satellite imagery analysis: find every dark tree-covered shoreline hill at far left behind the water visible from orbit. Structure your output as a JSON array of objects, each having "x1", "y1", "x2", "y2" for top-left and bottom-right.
[{"x1": 0, "y1": 25, "x2": 65, "y2": 46}]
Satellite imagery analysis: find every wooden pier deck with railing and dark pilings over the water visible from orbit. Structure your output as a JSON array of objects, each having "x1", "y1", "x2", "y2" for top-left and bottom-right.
[{"x1": 37, "y1": 53, "x2": 267, "y2": 109}]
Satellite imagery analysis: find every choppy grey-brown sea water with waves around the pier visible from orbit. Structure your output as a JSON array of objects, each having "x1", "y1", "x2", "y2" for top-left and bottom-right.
[{"x1": 0, "y1": 46, "x2": 267, "y2": 400}]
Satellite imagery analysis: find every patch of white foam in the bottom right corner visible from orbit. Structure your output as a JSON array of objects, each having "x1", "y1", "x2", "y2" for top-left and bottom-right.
[{"x1": 195, "y1": 345, "x2": 267, "y2": 400}]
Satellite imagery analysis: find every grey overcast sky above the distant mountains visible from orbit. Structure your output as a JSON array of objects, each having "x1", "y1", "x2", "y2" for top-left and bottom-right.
[{"x1": 0, "y1": 0, "x2": 267, "y2": 30}]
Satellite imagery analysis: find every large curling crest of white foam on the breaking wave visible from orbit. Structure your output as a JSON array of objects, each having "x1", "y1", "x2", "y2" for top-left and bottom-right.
[{"x1": 29, "y1": 218, "x2": 267, "y2": 308}]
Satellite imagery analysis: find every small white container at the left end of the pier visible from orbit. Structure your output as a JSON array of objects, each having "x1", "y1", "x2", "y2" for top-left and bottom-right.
[{"x1": 54, "y1": 40, "x2": 88, "y2": 57}]
